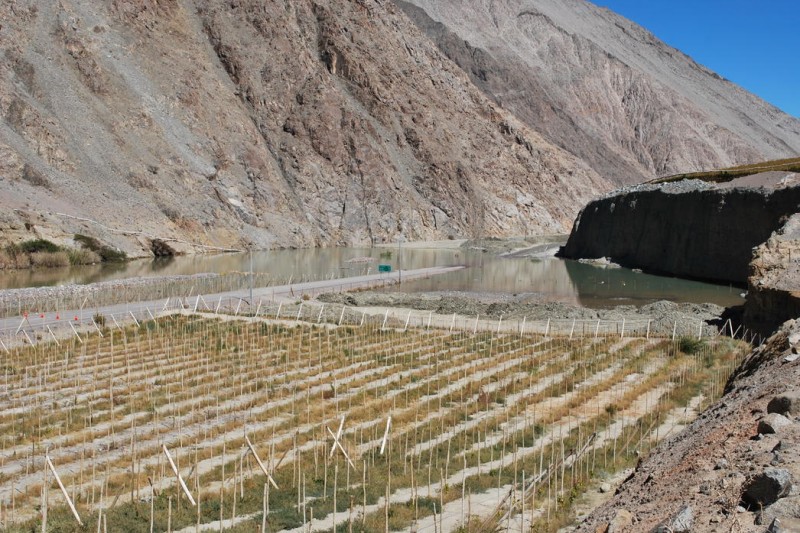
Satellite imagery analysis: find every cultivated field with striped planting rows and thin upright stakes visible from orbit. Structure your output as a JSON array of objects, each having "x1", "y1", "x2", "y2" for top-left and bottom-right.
[{"x1": 0, "y1": 314, "x2": 747, "y2": 532}]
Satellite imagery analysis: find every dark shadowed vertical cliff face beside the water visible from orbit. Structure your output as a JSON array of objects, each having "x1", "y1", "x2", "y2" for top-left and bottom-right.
[{"x1": 561, "y1": 182, "x2": 800, "y2": 284}]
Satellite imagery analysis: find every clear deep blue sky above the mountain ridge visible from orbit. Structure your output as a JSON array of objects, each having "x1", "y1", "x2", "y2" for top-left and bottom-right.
[{"x1": 592, "y1": 0, "x2": 800, "y2": 117}]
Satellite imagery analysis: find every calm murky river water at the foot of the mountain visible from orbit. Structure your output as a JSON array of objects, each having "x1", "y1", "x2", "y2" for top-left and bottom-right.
[{"x1": 0, "y1": 247, "x2": 744, "y2": 308}]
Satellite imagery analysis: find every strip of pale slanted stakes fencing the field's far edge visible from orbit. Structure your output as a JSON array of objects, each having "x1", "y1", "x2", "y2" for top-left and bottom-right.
[{"x1": 0, "y1": 288, "x2": 762, "y2": 349}]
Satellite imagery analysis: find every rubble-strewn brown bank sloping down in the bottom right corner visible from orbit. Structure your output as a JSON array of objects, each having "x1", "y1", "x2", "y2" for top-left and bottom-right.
[{"x1": 577, "y1": 321, "x2": 800, "y2": 533}]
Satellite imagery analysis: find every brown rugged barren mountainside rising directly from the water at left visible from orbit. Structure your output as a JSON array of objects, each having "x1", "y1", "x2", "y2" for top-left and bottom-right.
[{"x1": 0, "y1": 0, "x2": 609, "y2": 253}]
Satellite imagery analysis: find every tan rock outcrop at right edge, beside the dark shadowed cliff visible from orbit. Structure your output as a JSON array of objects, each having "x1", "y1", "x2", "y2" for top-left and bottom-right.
[{"x1": 744, "y1": 214, "x2": 800, "y2": 335}]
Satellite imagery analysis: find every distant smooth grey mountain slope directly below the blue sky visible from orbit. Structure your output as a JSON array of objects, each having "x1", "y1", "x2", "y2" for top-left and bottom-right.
[{"x1": 404, "y1": 0, "x2": 800, "y2": 183}]
